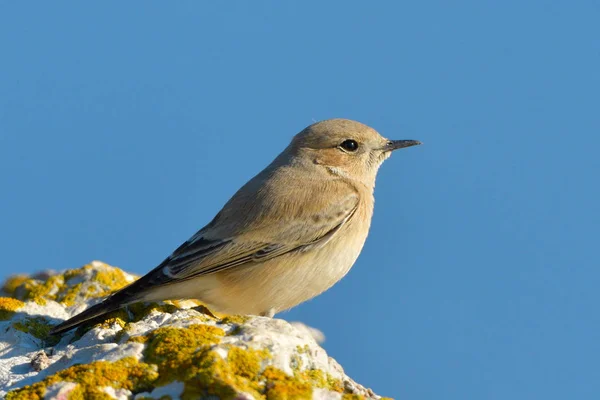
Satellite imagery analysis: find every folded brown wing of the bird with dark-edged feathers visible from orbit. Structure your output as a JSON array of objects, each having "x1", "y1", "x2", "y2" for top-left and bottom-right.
[{"x1": 148, "y1": 193, "x2": 359, "y2": 285}]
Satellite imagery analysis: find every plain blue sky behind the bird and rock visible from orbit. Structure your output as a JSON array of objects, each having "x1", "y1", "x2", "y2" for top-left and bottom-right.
[{"x1": 0, "y1": 1, "x2": 600, "y2": 399}]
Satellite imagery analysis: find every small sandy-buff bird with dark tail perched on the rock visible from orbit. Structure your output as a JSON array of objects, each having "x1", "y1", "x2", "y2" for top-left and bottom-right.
[{"x1": 51, "y1": 119, "x2": 421, "y2": 334}]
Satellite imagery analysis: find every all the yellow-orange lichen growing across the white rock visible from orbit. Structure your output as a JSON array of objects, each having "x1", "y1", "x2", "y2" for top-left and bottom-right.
[{"x1": 0, "y1": 264, "x2": 380, "y2": 400}]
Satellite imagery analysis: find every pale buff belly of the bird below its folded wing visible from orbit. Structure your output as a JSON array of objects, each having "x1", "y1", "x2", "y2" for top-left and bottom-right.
[{"x1": 201, "y1": 228, "x2": 366, "y2": 315}]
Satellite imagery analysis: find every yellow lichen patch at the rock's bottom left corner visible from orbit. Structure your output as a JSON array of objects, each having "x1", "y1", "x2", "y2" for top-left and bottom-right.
[{"x1": 6, "y1": 357, "x2": 158, "y2": 400}]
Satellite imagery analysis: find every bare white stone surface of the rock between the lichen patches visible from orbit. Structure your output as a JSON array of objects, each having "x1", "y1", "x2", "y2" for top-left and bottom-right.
[{"x1": 0, "y1": 262, "x2": 379, "y2": 400}]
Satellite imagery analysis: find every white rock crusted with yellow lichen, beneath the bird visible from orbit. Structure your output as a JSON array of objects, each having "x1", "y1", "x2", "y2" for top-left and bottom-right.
[{"x1": 0, "y1": 261, "x2": 380, "y2": 400}]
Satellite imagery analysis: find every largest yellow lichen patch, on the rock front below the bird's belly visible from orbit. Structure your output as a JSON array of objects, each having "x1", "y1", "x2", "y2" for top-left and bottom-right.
[{"x1": 138, "y1": 325, "x2": 343, "y2": 400}]
